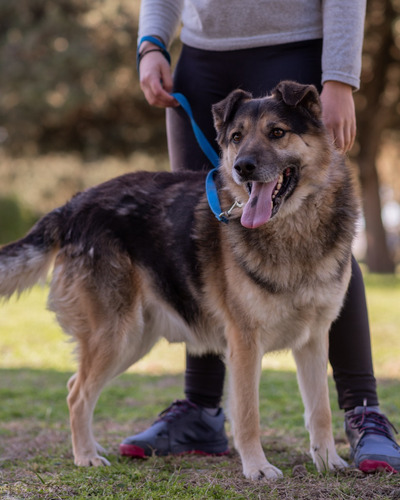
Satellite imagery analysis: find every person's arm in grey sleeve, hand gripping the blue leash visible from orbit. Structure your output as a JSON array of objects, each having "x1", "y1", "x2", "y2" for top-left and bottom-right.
[{"x1": 138, "y1": 0, "x2": 183, "y2": 108}]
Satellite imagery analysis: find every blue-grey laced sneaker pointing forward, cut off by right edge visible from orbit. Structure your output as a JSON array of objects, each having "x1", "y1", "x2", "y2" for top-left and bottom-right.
[{"x1": 345, "y1": 405, "x2": 400, "y2": 473}]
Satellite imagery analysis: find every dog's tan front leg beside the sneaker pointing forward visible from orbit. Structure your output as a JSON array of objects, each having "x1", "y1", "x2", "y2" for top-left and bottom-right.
[{"x1": 293, "y1": 328, "x2": 347, "y2": 471}]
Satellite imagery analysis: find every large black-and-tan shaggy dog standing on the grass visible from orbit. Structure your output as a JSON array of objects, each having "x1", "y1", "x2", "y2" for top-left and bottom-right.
[{"x1": 0, "y1": 82, "x2": 358, "y2": 479}]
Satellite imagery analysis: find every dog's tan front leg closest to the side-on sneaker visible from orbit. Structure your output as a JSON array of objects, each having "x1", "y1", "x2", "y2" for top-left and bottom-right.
[{"x1": 227, "y1": 326, "x2": 282, "y2": 480}]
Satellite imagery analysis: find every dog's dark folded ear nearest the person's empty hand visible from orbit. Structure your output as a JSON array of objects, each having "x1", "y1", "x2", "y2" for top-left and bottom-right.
[{"x1": 272, "y1": 81, "x2": 322, "y2": 120}]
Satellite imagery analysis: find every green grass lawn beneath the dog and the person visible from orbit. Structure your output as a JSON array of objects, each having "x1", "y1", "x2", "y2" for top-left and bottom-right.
[{"x1": 0, "y1": 274, "x2": 400, "y2": 500}]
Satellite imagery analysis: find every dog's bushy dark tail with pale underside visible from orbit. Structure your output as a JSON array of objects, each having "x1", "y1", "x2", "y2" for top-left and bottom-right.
[{"x1": 0, "y1": 209, "x2": 62, "y2": 298}]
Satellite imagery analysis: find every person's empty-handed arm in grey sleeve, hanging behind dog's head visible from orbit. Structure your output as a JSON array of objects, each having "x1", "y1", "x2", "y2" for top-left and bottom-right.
[{"x1": 321, "y1": 0, "x2": 366, "y2": 152}]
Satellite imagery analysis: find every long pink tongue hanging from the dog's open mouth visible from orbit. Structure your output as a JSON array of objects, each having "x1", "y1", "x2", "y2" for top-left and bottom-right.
[{"x1": 240, "y1": 180, "x2": 277, "y2": 229}]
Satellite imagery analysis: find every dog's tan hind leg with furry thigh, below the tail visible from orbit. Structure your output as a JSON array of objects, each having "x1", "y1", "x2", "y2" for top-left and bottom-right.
[{"x1": 49, "y1": 253, "x2": 159, "y2": 466}]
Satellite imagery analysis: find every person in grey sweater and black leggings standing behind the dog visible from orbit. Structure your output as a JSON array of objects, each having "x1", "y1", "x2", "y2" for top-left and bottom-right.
[{"x1": 120, "y1": 0, "x2": 400, "y2": 472}]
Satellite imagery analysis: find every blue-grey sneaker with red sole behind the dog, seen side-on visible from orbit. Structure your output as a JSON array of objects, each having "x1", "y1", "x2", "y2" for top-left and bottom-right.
[{"x1": 119, "y1": 399, "x2": 229, "y2": 458}]
